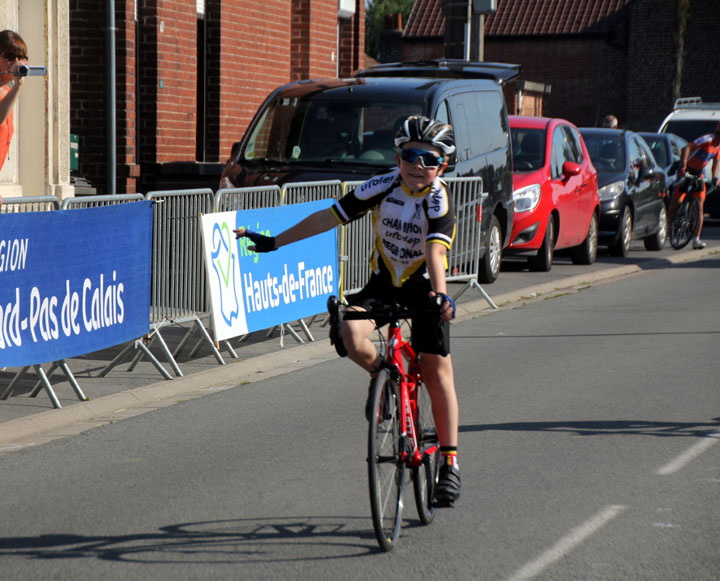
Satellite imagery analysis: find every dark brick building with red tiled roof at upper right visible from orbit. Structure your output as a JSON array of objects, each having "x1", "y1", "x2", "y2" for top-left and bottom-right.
[{"x1": 403, "y1": 0, "x2": 720, "y2": 130}]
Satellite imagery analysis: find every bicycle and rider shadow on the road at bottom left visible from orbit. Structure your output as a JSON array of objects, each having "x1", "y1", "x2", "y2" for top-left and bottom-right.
[{"x1": 0, "y1": 516, "x2": 390, "y2": 565}]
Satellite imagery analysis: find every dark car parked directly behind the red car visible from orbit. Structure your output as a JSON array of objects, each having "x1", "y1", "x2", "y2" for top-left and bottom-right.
[{"x1": 580, "y1": 127, "x2": 668, "y2": 256}]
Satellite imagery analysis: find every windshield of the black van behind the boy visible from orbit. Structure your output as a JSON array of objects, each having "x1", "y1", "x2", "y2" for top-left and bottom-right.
[{"x1": 241, "y1": 91, "x2": 423, "y2": 167}]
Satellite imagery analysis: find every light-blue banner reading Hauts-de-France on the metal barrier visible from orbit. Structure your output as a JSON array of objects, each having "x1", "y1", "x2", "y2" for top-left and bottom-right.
[{"x1": 201, "y1": 200, "x2": 340, "y2": 341}]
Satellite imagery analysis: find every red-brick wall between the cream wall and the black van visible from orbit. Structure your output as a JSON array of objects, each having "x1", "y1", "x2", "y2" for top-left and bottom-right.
[{"x1": 70, "y1": 0, "x2": 365, "y2": 193}]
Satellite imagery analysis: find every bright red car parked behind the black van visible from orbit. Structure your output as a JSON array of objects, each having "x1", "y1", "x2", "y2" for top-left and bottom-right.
[{"x1": 505, "y1": 116, "x2": 600, "y2": 271}]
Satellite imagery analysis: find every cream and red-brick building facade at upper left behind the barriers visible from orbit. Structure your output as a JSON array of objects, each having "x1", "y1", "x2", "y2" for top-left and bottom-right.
[{"x1": 0, "y1": 0, "x2": 365, "y2": 198}]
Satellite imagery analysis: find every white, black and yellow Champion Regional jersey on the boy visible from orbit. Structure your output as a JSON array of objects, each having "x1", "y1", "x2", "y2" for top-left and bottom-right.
[{"x1": 331, "y1": 169, "x2": 455, "y2": 287}]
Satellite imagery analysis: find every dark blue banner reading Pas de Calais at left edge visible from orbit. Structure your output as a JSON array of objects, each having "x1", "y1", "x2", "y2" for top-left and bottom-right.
[{"x1": 0, "y1": 201, "x2": 152, "y2": 367}]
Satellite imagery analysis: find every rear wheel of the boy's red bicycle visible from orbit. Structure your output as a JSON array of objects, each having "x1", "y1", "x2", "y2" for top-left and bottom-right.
[{"x1": 412, "y1": 384, "x2": 440, "y2": 525}]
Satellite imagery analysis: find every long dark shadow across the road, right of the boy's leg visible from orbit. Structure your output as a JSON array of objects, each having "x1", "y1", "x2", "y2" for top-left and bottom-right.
[{"x1": 459, "y1": 418, "x2": 720, "y2": 438}]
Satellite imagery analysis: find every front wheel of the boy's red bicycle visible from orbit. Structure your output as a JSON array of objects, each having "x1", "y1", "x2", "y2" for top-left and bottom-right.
[{"x1": 368, "y1": 369, "x2": 406, "y2": 551}]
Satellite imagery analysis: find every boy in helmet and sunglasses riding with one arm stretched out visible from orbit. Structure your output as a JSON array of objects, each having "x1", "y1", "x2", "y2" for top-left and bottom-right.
[{"x1": 234, "y1": 116, "x2": 460, "y2": 506}]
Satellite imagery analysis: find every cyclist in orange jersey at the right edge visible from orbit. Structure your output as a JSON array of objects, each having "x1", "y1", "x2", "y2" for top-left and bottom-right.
[{"x1": 668, "y1": 123, "x2": 720, "y2": 250}]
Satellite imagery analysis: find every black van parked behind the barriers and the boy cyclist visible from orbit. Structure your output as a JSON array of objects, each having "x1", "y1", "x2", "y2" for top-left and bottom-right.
[{"x1": 221, "y1": 60, "x2": 520, "y2": 283}]
